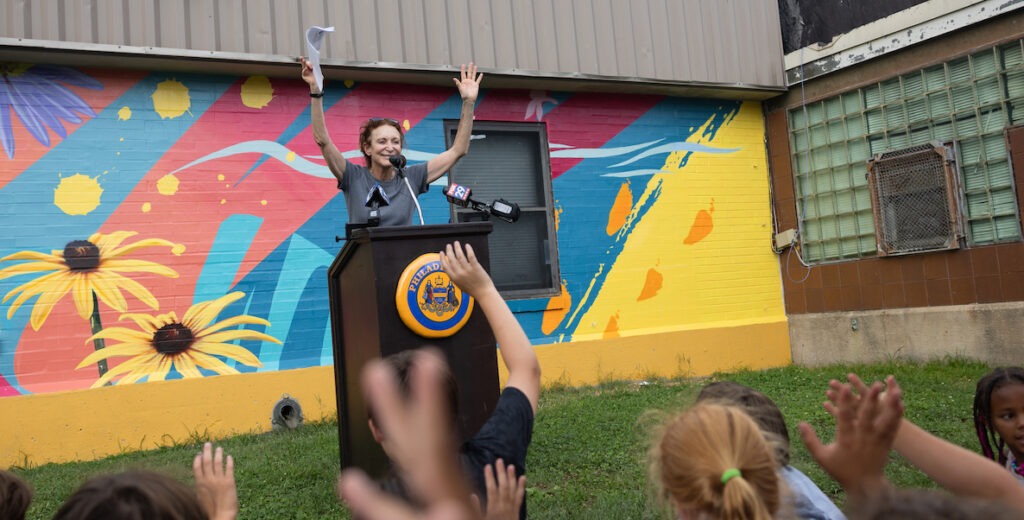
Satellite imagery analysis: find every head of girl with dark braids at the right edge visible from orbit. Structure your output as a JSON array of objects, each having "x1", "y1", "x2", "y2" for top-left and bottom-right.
[{"x1": 974, "y1": 366, "x2": 1024, "y2": 483}]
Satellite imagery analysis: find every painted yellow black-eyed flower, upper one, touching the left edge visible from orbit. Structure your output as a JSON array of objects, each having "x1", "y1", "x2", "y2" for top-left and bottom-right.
[{"x1": 0, "y1": 231, "x2": 184, "y2": 333}]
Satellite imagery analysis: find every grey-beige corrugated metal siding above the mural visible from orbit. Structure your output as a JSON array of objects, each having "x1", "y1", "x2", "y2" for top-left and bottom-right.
[{"x1": 0, "y1": 0, "x2": 783, "y2": 88}]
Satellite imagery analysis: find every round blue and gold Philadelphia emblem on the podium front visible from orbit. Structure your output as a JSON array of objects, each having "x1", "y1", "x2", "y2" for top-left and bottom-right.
[{"x1": 394, "y1": 253, "x2": 473, "y2": 338}]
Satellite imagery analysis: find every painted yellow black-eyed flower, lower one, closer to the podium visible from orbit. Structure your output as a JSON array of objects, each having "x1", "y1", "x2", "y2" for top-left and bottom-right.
[{"x1": 78, "y1": 291, "x2": 281, "y2": 388}]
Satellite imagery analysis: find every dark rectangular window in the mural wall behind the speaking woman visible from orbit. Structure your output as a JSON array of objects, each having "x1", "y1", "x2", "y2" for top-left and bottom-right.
[{"x1": 444, "y1": 120, "x2": 560, "y2": 298}]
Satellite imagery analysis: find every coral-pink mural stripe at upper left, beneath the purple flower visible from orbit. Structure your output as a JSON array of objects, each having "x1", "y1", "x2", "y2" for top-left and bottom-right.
[{"x1": 0, "y1": 69, "x2": 147, "y2": 189}]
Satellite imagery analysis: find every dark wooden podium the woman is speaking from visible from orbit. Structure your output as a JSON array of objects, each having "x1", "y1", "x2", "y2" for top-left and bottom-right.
[{"x1": 328, "y1": 222, "x2": 499, "y2": 476}]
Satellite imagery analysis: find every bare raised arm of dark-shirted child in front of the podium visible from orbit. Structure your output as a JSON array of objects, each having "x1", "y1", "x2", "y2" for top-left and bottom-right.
[{"x1": 440, "y1": 242, "x2": 541, "y2": 414}]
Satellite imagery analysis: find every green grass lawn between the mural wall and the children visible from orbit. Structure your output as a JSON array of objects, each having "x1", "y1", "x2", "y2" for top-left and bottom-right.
[{"x1": 13, "y1": 359, "x2": 989, "y2": 519}]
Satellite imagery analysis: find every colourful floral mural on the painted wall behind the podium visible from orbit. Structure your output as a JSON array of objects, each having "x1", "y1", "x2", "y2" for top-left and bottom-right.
[{"x1": 0, "y1": 63, "x2": 790, "y2": 464}]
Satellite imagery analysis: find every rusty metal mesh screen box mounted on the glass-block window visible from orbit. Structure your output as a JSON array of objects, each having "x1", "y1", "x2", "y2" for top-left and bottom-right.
[{"x1": 867, "y1": 141, "x2": 963, "y2": 256}]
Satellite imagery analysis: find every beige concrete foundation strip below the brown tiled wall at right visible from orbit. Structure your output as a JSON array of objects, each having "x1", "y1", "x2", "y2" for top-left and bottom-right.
[{"x1": 790, "y1": 302, "x2": 1024, "y2": 365}]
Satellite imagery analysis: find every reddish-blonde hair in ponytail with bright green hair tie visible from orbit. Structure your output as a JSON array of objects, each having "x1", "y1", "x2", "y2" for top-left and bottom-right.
[{"x1": 649, "y1": 402, "x2": 780, "y2": 520}]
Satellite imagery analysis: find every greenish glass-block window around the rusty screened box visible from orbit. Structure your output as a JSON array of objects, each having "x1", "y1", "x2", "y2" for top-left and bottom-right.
[{"x1": 788, "y1": 40, "x2": 1024, "y2": 262}]
